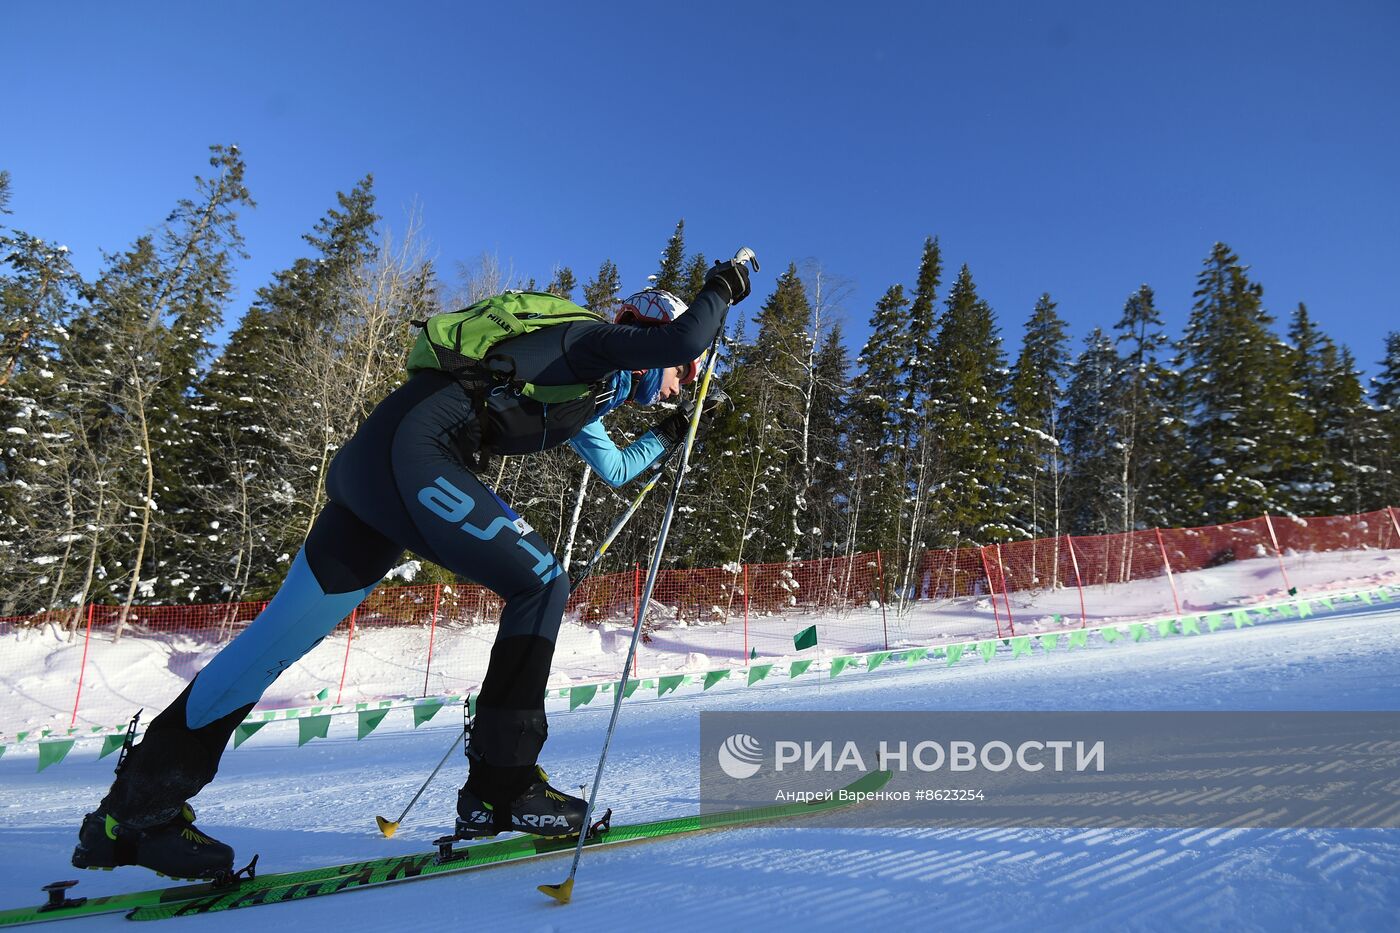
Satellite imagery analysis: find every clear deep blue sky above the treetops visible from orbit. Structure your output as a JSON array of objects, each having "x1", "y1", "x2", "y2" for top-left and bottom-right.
[{"x1": 0, "y1": 0, "x2": 1400, "y2": 374}]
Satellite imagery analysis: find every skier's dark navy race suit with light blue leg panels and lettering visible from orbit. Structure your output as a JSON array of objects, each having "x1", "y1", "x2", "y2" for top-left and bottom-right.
[{"x1": 104, "y1": 283, "x2": 728, "y2": 827}]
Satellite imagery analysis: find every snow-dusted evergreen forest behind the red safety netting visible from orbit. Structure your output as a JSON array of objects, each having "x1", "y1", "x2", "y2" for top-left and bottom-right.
[{"x1": 0, "y1": 146, "x2": 1400, "y2": 615}]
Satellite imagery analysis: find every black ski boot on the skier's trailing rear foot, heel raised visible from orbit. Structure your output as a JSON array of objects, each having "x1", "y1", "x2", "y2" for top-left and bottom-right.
[{"x1": 73, "y1": 804, "x2": 234, "y2": 881}]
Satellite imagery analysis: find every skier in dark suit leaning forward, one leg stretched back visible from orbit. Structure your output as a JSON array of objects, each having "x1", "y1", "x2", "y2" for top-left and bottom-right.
[{"x1": 73, "y1": 261, "x2": 749, "y2": 878}]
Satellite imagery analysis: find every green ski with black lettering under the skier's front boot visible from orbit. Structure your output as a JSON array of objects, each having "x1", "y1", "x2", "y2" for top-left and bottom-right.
[{"x1": 127, "y1": 770, "x2": 890, "y2": 920}]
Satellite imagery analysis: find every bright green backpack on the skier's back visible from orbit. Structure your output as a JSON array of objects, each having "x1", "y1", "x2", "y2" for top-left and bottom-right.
[{"x1": 409, "y1": 291, "x2": 606, "y2": 405}]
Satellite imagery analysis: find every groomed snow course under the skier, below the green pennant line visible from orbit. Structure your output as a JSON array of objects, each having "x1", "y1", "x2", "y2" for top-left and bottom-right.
[{"x1": 0, "y1": 609, "x2": 1400, "y2": 933}]
